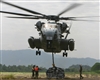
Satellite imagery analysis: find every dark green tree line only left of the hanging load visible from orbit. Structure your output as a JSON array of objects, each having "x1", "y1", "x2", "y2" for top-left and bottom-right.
[{"x1": 0, "y1": 64, "x2": 47, "y2": 72}]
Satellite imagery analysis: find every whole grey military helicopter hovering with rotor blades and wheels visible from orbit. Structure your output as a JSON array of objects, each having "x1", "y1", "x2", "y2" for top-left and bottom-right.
[{"x1": 0, "y1": 0, "x2": 98, "y2": 57}]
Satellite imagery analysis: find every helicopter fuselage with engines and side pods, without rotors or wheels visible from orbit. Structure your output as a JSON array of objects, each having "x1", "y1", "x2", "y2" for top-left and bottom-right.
[{"x1": 28, "y1": 21, "x2": 74, "y2": 53}]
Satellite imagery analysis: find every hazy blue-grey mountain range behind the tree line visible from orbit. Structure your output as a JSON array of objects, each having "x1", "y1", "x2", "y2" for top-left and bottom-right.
[{"x1": 0, "y1": 49, "x2": 99, "y2": 68}]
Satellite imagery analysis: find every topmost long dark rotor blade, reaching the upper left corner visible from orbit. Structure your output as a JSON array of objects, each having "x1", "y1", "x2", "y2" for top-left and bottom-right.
[{"x1": 0, "y1": 0, "x2": 45, "y2": 16}]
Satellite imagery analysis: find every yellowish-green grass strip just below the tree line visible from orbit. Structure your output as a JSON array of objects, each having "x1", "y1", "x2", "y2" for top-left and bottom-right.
[{"x1": 0, "y1": 72, "x2": 100, "y2": 79}]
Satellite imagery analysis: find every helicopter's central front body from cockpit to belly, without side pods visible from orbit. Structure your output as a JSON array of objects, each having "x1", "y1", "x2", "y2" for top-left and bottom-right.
[{"x1": 41, "y1": 22, "x2": 61, "y2": 52}]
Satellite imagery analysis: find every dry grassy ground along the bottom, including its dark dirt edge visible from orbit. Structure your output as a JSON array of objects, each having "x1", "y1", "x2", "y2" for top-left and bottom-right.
[{"x1": 0, "y1": 72, "x2": 100, "y2": 80}]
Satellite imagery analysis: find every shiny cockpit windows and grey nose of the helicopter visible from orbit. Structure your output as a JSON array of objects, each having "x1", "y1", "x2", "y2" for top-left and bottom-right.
[{"x1": 41, "y1": 23, "x2": 61, "y2": 40}]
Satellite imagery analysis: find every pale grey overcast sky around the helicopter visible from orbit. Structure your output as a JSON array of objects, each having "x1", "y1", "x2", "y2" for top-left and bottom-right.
[{"x1": 0, "y1": 0, "x2": 100, "y2": 59}]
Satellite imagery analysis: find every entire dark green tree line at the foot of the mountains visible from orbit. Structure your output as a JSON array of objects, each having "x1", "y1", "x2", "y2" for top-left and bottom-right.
[{"x1": 0, "y1": 63, "x2": 100, "y2": 73}]
